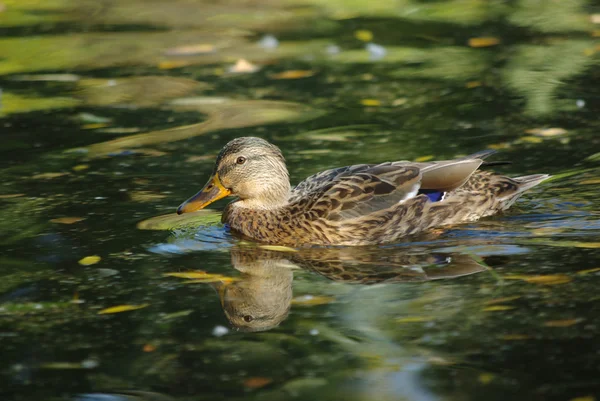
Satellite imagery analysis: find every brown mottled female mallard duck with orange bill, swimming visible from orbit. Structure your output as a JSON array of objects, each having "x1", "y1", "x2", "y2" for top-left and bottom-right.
[{"x1": 177, "y1": 137, "x2": 549, "y2": 246}]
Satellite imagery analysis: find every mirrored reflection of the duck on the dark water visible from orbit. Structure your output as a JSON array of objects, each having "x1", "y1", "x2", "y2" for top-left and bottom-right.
[{"x1": 212, "y1": 247, "x2": 486, "y2": 332}]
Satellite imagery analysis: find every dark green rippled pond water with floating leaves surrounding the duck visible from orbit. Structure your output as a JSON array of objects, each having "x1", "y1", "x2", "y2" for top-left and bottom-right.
[{"x1": 0, "y1": 0, "x2": 600, "y2": 401}]
